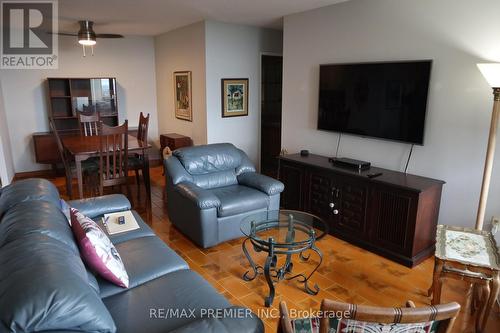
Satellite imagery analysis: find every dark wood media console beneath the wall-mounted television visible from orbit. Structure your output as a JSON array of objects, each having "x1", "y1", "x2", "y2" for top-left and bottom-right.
[{"x1": 279, "y1": 154, "x2": 445, "y2": 267}]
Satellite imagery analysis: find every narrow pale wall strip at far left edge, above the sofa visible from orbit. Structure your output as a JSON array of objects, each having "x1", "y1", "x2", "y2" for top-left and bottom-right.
[{"x1": 0, "y1": 82, "x2": 14, "y2": 187}]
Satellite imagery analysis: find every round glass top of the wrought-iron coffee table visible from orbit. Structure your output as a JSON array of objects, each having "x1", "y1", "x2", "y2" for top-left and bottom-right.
[{"x1": 240, "y1": 209, "x2": 326, "y2": 245}]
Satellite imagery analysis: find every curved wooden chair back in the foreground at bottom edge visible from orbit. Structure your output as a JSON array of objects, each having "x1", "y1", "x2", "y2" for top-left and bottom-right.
[{"x1": 279, "y1": 299, "x2": 460, "y2": 333}]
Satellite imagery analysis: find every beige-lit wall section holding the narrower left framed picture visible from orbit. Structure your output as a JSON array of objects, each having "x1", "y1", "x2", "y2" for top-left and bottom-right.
[{"x1": 155, "y1": 22, "x2": 207, "y2": 144}]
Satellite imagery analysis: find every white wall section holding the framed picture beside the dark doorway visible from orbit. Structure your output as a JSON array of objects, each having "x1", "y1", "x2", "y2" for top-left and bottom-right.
[{"x1": 205, "y1": 21, "x2": 283, "y2": 165}]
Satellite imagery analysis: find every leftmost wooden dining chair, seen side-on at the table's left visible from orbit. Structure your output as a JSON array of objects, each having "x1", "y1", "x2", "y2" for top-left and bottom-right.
[{"x1": 49, "y1": 119, "x2": 99, "y2": 199}]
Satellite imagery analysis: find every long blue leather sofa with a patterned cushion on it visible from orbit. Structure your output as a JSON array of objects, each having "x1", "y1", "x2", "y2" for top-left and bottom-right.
[{"x1": 0, "y1": 179, "x2": 264, "y2": 333}]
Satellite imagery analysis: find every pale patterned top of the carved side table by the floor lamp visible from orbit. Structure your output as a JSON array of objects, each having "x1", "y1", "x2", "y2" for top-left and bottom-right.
[{"x1": 436, "y1": 225, "x2": 500, "y2": 270}]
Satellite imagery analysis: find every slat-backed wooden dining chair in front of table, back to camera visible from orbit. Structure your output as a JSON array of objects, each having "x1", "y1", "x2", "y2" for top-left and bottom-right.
[{"x1": 99, "y1": 120, "x2": 131, "y2": 198}]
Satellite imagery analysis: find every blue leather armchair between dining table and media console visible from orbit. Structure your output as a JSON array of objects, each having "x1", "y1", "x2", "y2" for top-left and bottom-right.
[{"x1": 164, "y1": 143, "x2": 284, "y2": 248}]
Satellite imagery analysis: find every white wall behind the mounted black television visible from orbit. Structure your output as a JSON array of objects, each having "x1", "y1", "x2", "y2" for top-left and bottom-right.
[{"x1": 282, "y1": 0, "x2": 500, "y2": 232}]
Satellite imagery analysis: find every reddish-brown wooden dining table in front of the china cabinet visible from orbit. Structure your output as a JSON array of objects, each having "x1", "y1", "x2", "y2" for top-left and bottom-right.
[{"x1": 61, "y1": 134, "x2": 151, "y2": 203}]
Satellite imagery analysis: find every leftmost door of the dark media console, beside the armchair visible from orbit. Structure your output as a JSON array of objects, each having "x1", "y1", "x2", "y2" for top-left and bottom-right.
[{"x1": 279, "y1": 162, "x2": 304, "y2": 210}]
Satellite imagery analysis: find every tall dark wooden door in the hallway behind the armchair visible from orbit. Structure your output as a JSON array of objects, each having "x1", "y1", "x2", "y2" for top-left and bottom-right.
[{"x1": 260, "y1": 55, "x2": 283, "y2": 178}]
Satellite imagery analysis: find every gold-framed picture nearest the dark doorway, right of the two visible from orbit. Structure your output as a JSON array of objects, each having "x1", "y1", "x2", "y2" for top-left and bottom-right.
[{"x1": 221, "y1": 79, "x2": 248, "y2": 118}]
